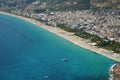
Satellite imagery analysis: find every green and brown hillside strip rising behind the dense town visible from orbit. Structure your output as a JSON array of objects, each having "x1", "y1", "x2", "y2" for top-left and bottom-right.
[{"x1": 0, "y1": 0, "x2": 120, "y2": 12}]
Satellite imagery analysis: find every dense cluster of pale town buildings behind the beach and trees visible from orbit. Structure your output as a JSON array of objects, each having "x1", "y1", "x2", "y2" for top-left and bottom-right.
[{"x1": 13, "y1": 10, "x2": 120, "y2": 41}]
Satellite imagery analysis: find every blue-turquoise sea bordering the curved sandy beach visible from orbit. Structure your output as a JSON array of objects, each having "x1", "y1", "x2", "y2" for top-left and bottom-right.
[{"x1": 0, "y1": 14, "x2": 116, "y2": 80}]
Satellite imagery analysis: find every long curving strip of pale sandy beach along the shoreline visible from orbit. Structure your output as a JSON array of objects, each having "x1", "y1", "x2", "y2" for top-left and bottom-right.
[{"x1": 0, "y1": 12, "x2": 120, "y2": 62}]
